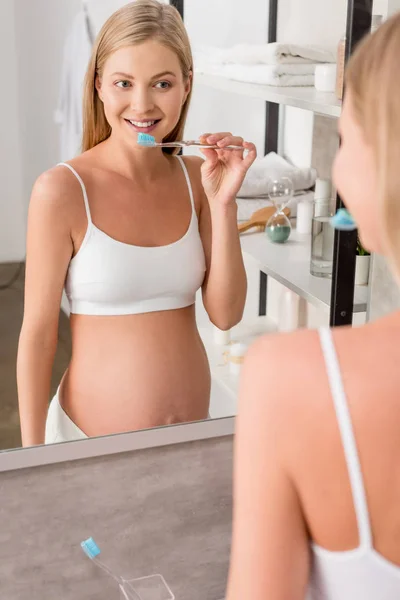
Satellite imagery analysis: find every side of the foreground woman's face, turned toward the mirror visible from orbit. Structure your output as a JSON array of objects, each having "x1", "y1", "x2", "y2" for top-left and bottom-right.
[{"x1": 333, "y1": 92, "x2": 382, "y2": 253}]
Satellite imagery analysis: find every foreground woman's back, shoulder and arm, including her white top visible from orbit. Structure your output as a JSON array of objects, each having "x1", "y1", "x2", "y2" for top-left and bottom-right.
[{"x1": 228, "y1": 314, "x2": 400, "y2": 600}]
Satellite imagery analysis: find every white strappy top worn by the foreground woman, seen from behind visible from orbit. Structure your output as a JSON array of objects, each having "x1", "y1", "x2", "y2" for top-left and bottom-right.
[{"x1": 307, "y1": 329, "x2": 400, "y2": 600}]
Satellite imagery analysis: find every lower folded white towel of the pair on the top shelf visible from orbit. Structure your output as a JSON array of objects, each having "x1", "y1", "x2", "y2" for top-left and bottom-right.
[{"x1": 195, "y1": 63, "x2": 315, "y2": 87}]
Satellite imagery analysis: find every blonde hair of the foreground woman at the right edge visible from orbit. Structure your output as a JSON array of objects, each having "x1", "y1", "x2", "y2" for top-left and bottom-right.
[{"x1": 345, "y1": 14, "x2": 400, "y2": 275}]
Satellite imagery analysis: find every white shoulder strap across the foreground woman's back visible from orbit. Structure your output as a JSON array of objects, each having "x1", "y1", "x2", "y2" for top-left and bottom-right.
[{"x1": 319, "y1": 328, "x2": 372, "y2": 548}]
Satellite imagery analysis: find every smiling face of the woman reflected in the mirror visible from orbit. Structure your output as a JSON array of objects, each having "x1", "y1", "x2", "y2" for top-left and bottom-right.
[{"x1": 96, "y1": 40, "x2": 191, "y2": 146}]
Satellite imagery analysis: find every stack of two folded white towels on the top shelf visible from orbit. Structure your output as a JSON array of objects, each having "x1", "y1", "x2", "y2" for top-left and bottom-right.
[{"x1": 194, "y1": 42, "x2": 336, "y2": 87}]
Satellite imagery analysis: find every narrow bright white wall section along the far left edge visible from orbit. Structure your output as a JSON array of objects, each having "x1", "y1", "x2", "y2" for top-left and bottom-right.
[{"x1": 0, "y1": 0, "x2": 25, "y2": 262}]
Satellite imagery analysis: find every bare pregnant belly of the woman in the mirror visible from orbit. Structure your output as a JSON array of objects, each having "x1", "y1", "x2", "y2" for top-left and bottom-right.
[{"x1": 60, "y1": 307, "x2": 210, "y2": 436}]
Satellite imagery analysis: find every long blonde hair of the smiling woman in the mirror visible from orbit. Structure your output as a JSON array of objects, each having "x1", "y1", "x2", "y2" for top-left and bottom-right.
[{"x1": 82, "y1": 0, "x2": 193, "y2": 154}]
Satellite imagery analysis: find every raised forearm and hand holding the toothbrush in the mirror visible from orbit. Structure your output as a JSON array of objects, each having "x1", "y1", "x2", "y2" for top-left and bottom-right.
[{"x1": 196, "y1": 133, "x2": 256, "y2": 330}]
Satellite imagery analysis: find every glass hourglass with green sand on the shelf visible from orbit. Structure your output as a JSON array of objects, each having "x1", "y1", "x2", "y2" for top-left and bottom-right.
[{"x1": 265, "y1": 177, "x2": 293, "y2": 244}]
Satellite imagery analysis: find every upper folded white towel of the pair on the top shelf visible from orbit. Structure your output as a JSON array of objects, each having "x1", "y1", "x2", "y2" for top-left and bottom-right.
[{"x1": 195, "y1": 42, "x2": 336, "y2": 65}]
